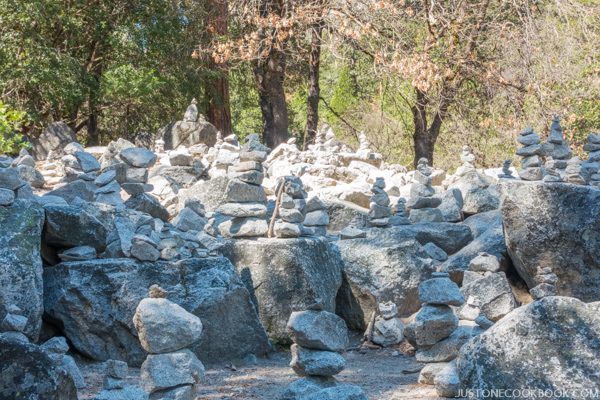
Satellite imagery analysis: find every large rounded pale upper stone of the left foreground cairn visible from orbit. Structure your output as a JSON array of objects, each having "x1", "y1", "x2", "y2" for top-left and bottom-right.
[{"x1": 133, "y1": 298, "x2": 202, "y2": 354}]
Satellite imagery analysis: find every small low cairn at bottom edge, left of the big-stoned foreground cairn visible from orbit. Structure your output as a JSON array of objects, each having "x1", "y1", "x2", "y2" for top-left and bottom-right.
[{"x1": 94, "y1": 360, "x2": 148, "y2": 400}]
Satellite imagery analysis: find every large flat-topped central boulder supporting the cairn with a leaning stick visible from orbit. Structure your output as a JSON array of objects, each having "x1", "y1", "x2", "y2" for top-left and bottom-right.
[{"x1": 224, "y1": 238, "x2": 342, "y2": 342}]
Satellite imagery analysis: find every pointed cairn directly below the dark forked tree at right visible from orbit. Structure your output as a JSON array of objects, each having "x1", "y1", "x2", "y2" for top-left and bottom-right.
[{"x1": 407, "y1": 158, "x2": 444, "y2": 223}]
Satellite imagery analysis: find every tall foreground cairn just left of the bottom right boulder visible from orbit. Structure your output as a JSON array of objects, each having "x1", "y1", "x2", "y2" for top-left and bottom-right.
[{"x1": 404, "y1": 272, "x2": 470, "y2": 397}]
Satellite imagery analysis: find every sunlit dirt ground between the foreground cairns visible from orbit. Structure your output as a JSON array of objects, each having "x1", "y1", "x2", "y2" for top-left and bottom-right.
[{"x1": 78, "y1": 342, "x2": 439, "y2": 400}]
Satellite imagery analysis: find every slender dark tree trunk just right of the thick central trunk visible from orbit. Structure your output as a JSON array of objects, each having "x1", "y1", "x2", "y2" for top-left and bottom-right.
[{"x1": 303, "y1": 24, "x2": 322, "y2": 150}]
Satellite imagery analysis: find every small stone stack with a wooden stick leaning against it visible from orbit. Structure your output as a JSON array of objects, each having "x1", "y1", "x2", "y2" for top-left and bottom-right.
[{"x1": 273, "y1": 176, "x2": 306, "y2": 238}]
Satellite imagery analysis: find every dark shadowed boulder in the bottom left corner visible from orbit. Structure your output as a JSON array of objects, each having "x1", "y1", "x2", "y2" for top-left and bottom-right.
[{"x1": 0, "y1": 333, "x2": 77, "y2": 400}]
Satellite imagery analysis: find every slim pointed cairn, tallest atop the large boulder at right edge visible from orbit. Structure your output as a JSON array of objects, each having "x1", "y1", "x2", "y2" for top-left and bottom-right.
[{"x1": 542, "y1": 117, "x2": 573, "y2": 182}]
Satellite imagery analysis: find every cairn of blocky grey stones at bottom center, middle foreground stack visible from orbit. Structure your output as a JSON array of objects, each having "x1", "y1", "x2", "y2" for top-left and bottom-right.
[{"x1": 281, "y1": 310, "x2": 367, "y2": 400}]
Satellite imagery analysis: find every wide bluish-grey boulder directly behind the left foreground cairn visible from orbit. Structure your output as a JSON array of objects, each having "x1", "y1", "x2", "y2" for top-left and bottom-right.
[{"x1": 44, "y1": 257, "x2": 269, "y2": 366}]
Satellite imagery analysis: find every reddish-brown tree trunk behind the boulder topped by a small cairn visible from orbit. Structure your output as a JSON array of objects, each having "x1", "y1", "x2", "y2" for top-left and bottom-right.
[{"x1": 206, "y1": 0, "x2": 233, "y2": 136}]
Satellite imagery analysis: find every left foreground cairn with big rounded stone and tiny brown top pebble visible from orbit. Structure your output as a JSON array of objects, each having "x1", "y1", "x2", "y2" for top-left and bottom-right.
[{"x1": 133, "y1": 285, "x2": 204, "y2": 400}]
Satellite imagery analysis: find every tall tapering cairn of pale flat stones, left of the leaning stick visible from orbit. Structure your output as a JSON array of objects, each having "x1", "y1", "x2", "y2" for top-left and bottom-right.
[{"x1": 217, "y1": 134, "x2": 269, "y2": 238}]
